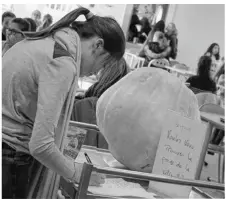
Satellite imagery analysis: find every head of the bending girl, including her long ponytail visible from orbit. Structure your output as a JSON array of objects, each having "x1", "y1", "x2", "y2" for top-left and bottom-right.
[{"x1": 26, "y1": 7, "x2": 125, "y2": 76}]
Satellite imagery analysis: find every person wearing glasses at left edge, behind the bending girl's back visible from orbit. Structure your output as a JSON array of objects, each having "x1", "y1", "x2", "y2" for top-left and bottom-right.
[{"x1": 2, "y1": 18, "x2": 30, "y2": 56}]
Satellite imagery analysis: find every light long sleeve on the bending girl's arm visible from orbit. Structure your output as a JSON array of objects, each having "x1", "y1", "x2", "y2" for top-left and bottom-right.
[{"x1": 29, "y1": 57, "x2": 79, "y2": 182}]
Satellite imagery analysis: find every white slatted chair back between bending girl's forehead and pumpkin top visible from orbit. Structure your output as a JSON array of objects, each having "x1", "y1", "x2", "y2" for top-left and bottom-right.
[{"x1": 124, "y1": 52, "x2": 145, "y2": 70}]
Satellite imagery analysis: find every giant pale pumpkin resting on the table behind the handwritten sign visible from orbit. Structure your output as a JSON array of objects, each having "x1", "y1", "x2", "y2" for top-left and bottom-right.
[{"x1": 96, "y1": 68, "x2": 200, "y2": 172}]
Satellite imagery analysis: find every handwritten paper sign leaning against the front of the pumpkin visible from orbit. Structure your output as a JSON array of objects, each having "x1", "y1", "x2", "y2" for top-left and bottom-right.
[{"x1": 149, "y1": 110, "x2": 206, "y2": 198}]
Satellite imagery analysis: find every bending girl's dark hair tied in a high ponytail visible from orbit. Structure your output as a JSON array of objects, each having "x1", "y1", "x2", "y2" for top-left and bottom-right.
[{"x1": 26, "y1": 7, "x2": 125, "y2": 60}]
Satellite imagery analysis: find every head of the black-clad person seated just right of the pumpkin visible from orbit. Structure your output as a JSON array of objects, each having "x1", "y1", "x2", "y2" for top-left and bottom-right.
[{"x1": 197, "y1": 56, "x2": 216, "y2": 79}]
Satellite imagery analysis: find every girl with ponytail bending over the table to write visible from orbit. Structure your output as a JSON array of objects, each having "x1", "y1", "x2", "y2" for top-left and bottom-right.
[{"x1": 2, "y1": 7, "x2": 125, "y2": 198}]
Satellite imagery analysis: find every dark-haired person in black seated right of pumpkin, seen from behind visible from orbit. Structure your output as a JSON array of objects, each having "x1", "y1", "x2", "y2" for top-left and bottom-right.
[{"x1": 186, "y1": 56, "x2": 217, "y2": 93}]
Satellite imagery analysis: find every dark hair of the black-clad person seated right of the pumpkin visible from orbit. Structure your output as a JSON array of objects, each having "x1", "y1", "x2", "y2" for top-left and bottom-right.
[{"x1": 197, "y1": 56, "x2": 212, "y2": 78}]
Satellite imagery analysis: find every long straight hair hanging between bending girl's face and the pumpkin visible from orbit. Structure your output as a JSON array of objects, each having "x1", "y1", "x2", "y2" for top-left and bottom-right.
[{"x1": 85, "y1": 58, "x2": 129, "y2": 98}]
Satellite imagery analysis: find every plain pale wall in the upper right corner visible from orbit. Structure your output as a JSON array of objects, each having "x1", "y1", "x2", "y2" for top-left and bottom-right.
[{"x1": 172, "y1": 4, "x2": 225, "y2": 70}]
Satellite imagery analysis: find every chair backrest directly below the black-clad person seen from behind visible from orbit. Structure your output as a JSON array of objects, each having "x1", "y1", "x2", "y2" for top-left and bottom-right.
[{"x1": 196, "y1": 92, "x2": 219, "y2": 107}]
